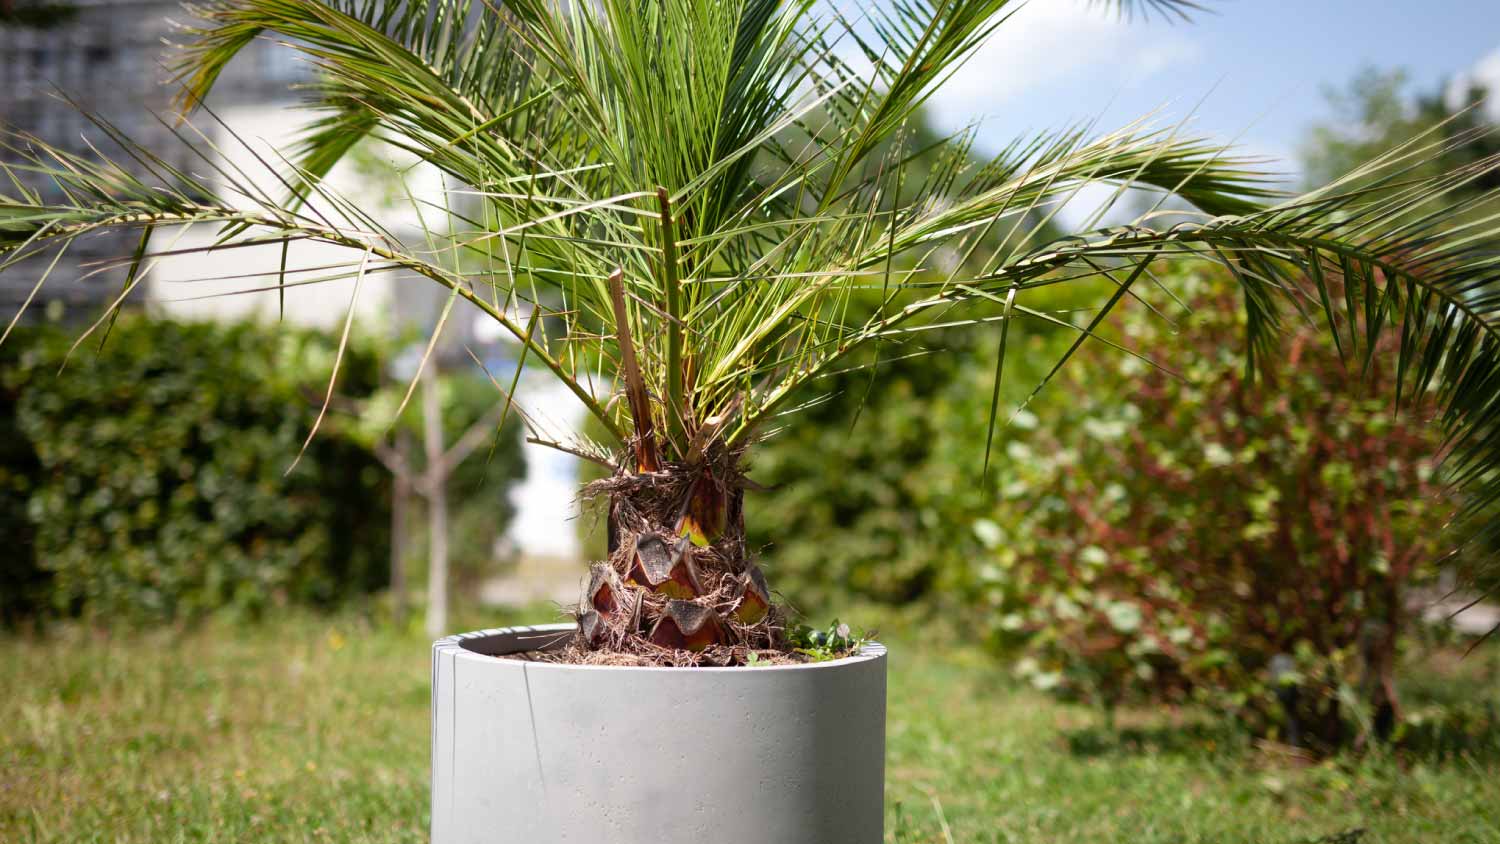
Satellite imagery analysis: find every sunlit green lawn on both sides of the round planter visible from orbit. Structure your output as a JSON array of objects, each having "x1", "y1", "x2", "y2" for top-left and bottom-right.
[{"x1": 0, "y1": 610, "x2": 1500, "y2": 844}]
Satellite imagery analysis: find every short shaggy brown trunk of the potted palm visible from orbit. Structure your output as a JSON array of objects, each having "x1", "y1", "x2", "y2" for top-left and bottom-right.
[{"x1": 578, "y1": 453, "x2": 782, "y2": 664}]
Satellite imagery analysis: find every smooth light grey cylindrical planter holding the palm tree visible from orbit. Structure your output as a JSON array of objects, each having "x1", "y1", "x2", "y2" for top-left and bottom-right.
[{"x1": 432, "y1": 624, "x2": 885, "y2": 844}]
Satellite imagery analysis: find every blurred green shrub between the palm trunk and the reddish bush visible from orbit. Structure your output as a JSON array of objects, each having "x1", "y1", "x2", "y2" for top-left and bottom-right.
[{"x1": 746, "y1": 295, "x2": 1074, "y2": 612}]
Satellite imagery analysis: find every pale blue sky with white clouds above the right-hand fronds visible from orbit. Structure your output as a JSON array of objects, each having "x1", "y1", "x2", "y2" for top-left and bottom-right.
[{"x1": 933, "y1": 0, "x2": 1500, "y2": 179}]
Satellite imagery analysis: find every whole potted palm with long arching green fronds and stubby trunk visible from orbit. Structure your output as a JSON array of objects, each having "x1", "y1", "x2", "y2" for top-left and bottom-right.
[{"x1": 0, "y1": 0, "x2": 1500, "y2": 661}]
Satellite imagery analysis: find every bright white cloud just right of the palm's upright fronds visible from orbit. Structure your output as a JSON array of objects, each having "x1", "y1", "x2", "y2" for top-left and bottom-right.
[{"x1": 933, "y1": 0, "x2": 1199, "y2": 124}]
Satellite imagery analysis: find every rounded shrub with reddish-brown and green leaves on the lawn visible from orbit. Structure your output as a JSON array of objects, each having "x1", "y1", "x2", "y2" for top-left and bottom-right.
[{"x1": 975, "y1": 266, "x2": 1451, "y2": 744}]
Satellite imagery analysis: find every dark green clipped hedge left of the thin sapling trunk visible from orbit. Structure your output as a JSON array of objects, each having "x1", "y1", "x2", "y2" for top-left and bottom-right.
[{"x1": 0, "y1": 316, "x2": 389, "y2": 621}]
